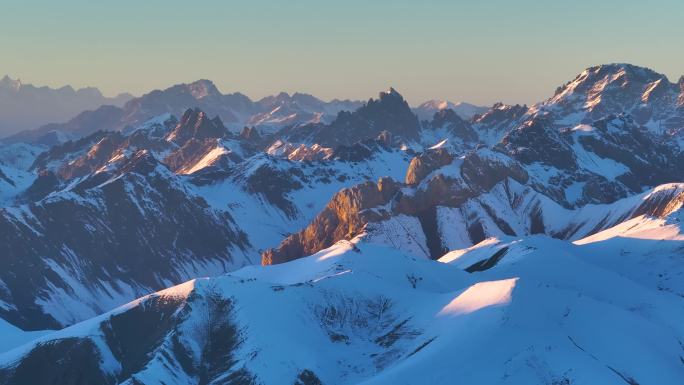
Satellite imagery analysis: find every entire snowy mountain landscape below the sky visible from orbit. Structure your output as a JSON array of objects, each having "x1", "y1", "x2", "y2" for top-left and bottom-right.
[{"x1": 0, "y1": 64, "x2": 684, "y2": 385}]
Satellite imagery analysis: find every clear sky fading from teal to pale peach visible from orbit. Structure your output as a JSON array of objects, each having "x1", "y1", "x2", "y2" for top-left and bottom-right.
[{"x1": 0, "y1": 0, "x2": 684, "y2": 104}]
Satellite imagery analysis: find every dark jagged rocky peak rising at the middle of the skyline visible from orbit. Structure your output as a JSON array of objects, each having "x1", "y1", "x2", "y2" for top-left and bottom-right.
[{"x1": 280, "y1": 89, "x2": 420, "y2": 149}]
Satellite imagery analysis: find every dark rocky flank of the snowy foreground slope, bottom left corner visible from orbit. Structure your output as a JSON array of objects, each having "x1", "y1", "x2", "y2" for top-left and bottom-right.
[{"x1": 0, "y1": 290, "x2": 256, "y2": 385}]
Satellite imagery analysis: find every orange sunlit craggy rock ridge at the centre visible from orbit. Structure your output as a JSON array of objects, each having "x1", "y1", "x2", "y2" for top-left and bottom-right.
[{"x1": 261, "y1": 178, "x2": 400, "y2": 265}]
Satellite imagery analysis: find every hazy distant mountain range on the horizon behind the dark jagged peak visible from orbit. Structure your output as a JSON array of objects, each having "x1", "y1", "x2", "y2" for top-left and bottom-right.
[{"x1": 0, "y1": 76, "x2": 487, "y2": 145}]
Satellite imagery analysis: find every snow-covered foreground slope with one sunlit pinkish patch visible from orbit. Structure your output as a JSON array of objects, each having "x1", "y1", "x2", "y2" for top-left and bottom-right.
[{"x1": 0, "y1": 196, "x2": 684, "y2": 384}]
